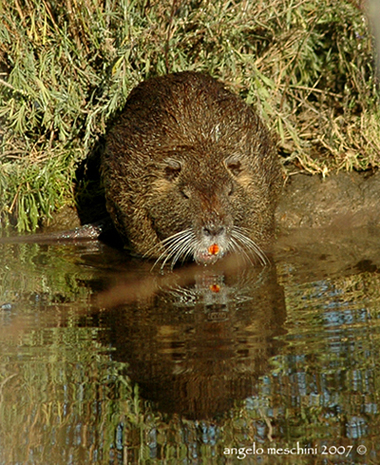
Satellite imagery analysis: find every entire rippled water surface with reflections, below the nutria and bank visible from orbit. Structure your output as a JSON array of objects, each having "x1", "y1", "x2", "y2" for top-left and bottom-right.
[{"x1": 0, "y1": 230, "x2": 380, "y2": 465}]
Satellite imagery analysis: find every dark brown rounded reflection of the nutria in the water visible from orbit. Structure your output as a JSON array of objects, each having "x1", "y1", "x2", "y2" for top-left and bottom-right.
[{"x1": 95, "y1": 266, "x2": 286, "y2": 420}]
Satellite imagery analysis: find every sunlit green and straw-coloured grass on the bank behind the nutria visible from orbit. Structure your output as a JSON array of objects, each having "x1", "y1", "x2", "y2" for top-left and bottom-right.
[{"x1": 0, "y1": 0, "x2": 380, "y2": 229}]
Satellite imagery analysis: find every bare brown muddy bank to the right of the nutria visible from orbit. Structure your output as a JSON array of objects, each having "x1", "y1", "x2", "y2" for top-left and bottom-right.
[{"x1": 276, "y1": 172, "x2": 380, "y2": 230}]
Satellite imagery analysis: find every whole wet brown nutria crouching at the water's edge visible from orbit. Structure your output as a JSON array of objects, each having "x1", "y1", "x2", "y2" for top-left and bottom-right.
[{"x1": 101, "y1": 72, "x2": 280, "y2": 267}]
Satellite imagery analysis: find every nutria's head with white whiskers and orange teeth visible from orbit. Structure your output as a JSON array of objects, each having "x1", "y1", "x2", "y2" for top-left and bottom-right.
[{"x1": 149, "y1": 147, "x2": 274, "y2": 264}]
